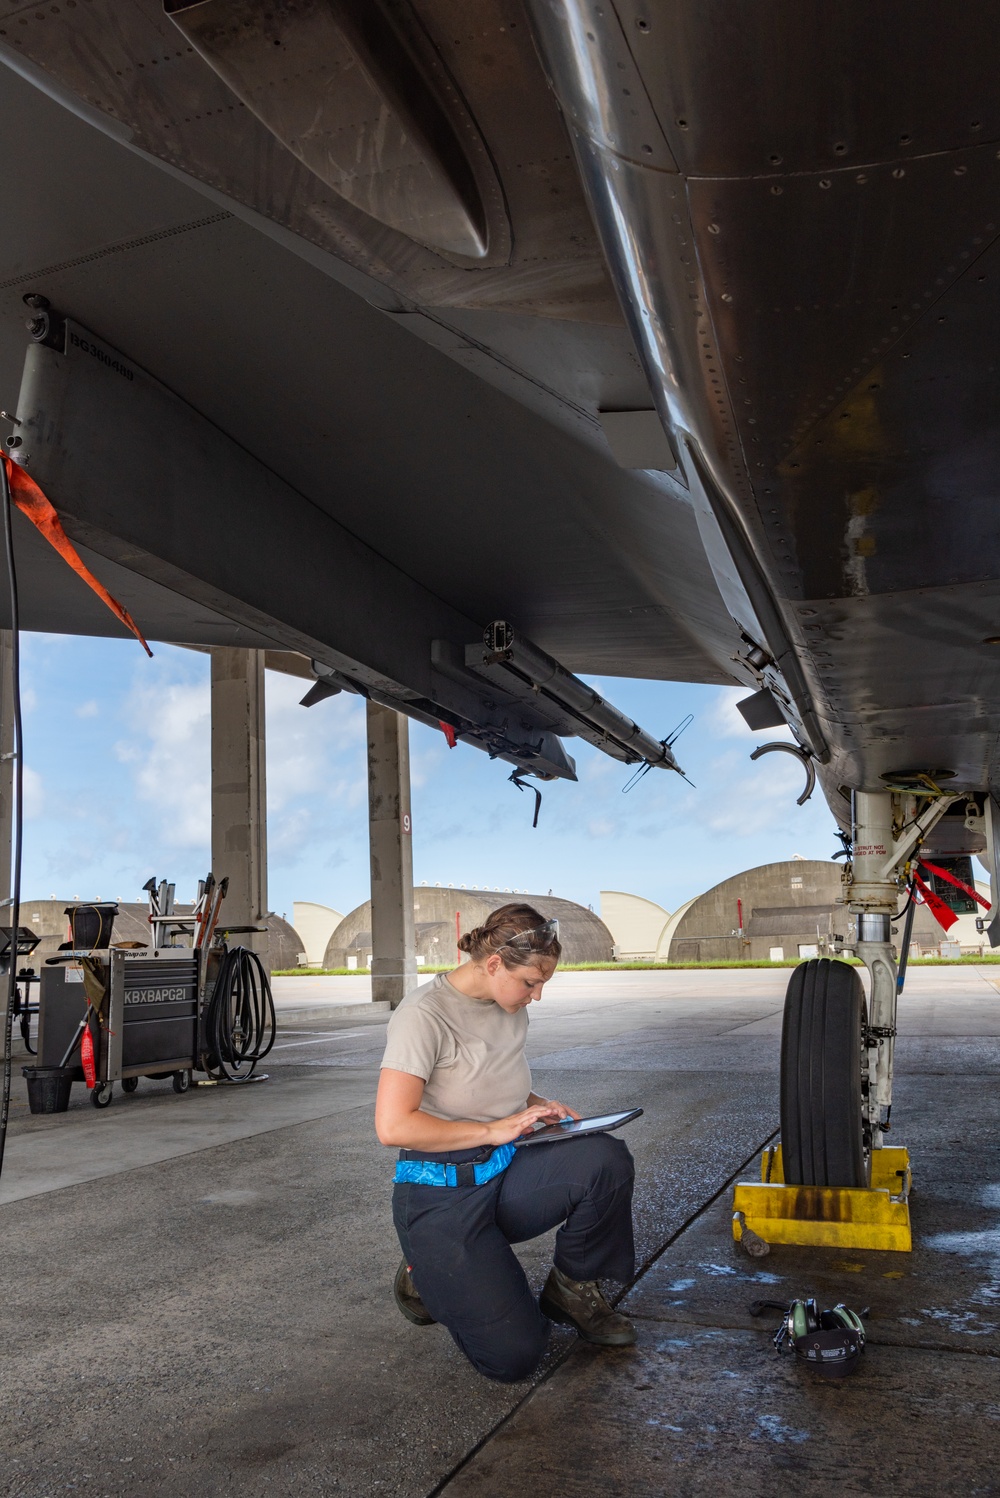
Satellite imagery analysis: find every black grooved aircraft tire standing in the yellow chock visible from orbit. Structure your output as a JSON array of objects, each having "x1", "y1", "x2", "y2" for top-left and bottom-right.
[{"x1": 781, "y1": 957, "x2": 871, "y2": 1186}]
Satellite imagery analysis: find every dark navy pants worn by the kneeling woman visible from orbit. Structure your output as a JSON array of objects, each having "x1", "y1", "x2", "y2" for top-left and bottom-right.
[{"x1": 392, "y1": 1134, "x2": 635, "y2": 1383}]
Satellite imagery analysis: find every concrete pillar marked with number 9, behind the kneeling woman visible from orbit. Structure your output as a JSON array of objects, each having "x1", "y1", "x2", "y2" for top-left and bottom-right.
[{"x1": 367, "y1": 701, "x2": 416, "y2": 1008}]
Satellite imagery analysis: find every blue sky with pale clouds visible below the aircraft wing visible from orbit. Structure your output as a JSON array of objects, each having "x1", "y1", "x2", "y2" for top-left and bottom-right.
[{"x1": 22, "y1": 634, "x2": 837, "y2": 918}]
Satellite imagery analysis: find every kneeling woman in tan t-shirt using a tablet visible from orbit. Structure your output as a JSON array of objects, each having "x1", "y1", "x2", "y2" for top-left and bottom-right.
[{"x1": 376, "y1": 905, "x2": 635, "y2": 1383}]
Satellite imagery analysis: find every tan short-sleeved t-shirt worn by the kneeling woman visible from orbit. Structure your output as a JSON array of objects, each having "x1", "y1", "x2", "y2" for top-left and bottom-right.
[{"x1": 382, "y1": 972, "x2": 531, "y2": 1124}]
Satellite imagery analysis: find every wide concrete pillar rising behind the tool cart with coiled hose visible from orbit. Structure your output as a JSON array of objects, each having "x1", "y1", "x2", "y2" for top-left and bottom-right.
[{"x1": 211, "y1": 647, "x2": 268, "y2": 957}]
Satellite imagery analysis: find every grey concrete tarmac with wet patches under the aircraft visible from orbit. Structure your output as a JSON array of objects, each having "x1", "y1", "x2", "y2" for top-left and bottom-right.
[{"x1": 0, "y1": 968, "x2": 1000, "y2": 1498}]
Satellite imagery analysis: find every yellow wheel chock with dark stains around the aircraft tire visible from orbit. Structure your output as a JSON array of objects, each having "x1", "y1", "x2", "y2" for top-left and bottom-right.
[{"x1": 732, "y1": 1144, "x2": 913, "y2": 1254}]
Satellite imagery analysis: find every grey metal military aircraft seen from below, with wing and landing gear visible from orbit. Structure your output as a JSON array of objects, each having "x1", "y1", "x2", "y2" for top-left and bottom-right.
[{"x1": 0, "y1": 0, "x2": 1000, "y2": 1185}]
